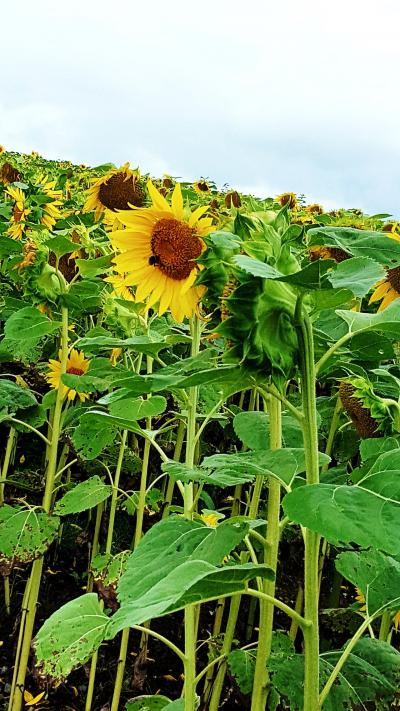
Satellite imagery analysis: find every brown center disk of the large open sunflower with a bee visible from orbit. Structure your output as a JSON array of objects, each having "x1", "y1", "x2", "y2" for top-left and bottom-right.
[{"x1": 149, "y1": 217, "x2": 202, "y2": 281}]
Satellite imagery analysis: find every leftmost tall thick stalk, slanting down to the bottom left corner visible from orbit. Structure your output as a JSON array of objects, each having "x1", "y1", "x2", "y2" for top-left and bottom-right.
[{"x1": 9, "y1": 307, "x2": 68, "y2": 711}]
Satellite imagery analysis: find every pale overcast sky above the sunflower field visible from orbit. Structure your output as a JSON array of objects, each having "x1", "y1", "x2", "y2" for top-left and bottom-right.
[{"x1": 0, "y1": 0, "x2": 400, "y2": 217}]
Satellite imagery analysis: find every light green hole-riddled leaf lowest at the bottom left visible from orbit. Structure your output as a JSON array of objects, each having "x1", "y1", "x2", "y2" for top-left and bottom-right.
[{"x1": 33, "y1": 593, "x2": 109, "y2": 679}]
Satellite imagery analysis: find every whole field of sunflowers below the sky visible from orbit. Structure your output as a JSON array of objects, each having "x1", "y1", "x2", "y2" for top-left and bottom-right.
[{"x1": 0, "y1": 147, "x2": 400, "y2": 711}]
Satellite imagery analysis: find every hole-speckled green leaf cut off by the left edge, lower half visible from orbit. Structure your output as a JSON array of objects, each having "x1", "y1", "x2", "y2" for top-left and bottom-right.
[{"x1": 0, "y1": 504, "x2": 60, "y2": 567}]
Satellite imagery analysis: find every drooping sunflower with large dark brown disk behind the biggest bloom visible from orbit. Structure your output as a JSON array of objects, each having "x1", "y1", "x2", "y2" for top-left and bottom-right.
[{"x1": 83, "y1": 163, "x2": 144, "y2": 220}]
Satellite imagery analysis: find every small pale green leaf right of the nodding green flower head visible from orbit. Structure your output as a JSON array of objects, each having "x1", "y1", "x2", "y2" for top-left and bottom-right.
[{"x1": 329, "y1": 257, "x2": 386, "y2": 298}]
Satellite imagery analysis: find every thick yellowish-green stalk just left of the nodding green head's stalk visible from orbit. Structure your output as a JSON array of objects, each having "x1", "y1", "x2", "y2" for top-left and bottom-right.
[{"x1": 251, "y1": 396, "x2": 282, "y2": 711}]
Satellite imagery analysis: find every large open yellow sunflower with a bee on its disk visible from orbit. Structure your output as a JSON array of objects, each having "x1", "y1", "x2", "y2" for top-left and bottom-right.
[{"x1": 110, "y1": 180, "x2": 213, "y2": 322}]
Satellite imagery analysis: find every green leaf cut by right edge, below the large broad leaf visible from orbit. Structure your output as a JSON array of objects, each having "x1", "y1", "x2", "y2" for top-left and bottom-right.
[{"x1": 335, "y1": 549, "x2": 400, "y2": 615}]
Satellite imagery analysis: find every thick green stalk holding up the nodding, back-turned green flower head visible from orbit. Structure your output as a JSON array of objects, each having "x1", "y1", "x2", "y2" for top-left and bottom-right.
[{"x1": 296, "y1": 298, "x2": 320, "y2": 711}]
